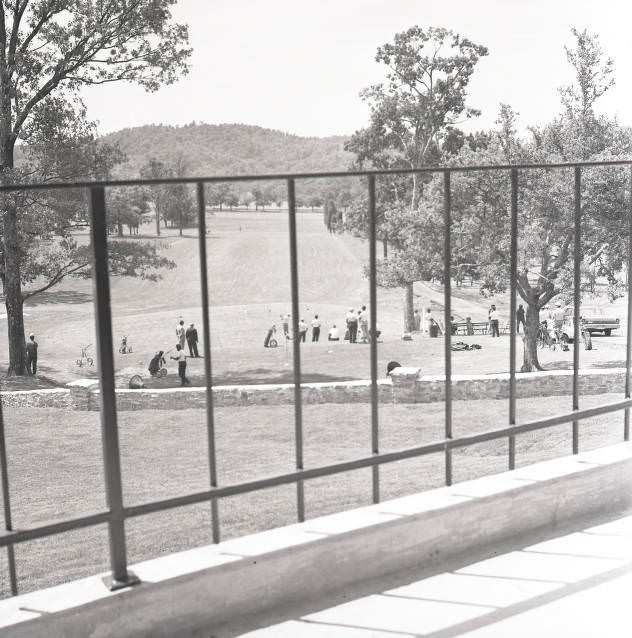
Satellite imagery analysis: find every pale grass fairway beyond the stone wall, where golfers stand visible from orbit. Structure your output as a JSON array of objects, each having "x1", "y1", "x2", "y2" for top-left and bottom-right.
[{"x1": 0, "y1": 212, "x2": 625, "y2": 389}]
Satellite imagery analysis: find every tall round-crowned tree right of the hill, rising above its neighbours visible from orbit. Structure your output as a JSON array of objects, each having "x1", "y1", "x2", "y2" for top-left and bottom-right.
[{"x1": 345, "y1": 26, "x2": 487, "y2": 330}]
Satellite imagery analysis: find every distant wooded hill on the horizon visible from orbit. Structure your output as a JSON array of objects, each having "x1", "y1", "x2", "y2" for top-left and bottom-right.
[{"x1": 102, "y1": 124, "x2": 353, "y2": 203}]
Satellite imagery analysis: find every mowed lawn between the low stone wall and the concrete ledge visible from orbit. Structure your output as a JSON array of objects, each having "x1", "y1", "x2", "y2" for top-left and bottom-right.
[{"x1": 0, "y1": 395, "x2": 623, "y2": 596}]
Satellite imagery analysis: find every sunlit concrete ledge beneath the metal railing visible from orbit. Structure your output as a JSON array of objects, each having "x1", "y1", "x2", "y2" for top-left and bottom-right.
[{"x1": 0, "y1": 443, "x2": 632, "y2": 638}]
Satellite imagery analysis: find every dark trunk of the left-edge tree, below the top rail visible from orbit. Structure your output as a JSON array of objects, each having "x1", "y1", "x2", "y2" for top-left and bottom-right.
[{"x1": 4, "y1": 198, "x2": 27, "y2": 376}]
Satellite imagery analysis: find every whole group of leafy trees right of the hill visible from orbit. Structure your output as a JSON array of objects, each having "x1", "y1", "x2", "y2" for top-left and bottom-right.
[{"x1": 343, "y1": 27, "x2": 632, "y2": 371}]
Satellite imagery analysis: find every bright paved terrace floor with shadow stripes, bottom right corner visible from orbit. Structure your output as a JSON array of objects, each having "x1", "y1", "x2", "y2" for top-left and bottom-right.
[{"x1": 222, "y1": 511, "x2": 632, "y2": 638}]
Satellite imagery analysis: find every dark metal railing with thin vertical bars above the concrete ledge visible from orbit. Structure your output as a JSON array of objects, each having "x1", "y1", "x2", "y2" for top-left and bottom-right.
[{"x1": 0, "y1": 160, "x2": 632, "y2": 595}]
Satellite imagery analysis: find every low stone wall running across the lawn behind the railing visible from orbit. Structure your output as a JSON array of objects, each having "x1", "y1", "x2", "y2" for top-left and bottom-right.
[{"x1": 0, "y1": 367, "x2": 625, "y2": 411}]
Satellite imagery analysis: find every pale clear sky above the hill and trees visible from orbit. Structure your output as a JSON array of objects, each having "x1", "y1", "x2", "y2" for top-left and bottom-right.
[{"x1": 83, "y1": 0, "x2": 632, "y2": 137}]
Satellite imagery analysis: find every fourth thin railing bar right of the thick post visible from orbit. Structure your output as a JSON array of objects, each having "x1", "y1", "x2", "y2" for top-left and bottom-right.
[{"x1": 443, "y1": 171, "x2": 452, "y2": 485}]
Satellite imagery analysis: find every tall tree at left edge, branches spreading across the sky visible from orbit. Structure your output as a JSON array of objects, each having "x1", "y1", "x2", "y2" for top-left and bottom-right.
[{"x1": 0, "y1": 0, "x2": 190, "y2": 374}]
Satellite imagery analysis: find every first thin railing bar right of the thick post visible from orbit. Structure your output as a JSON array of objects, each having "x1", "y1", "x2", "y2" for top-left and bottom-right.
[{"x1": 197, "y1": 182, "x2": 219, "y2": 543}]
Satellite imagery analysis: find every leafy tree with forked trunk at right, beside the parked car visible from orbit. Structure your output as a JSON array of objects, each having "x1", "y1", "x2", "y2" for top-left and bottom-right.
[{"x1": 442, "y1": 29, "x2": 632, "y2": 372}]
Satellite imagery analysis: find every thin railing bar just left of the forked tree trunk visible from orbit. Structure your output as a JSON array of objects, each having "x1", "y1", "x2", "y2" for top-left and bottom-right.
[{"x1": 509, "y1": 168, "x2": 524, "y2": 470}]
